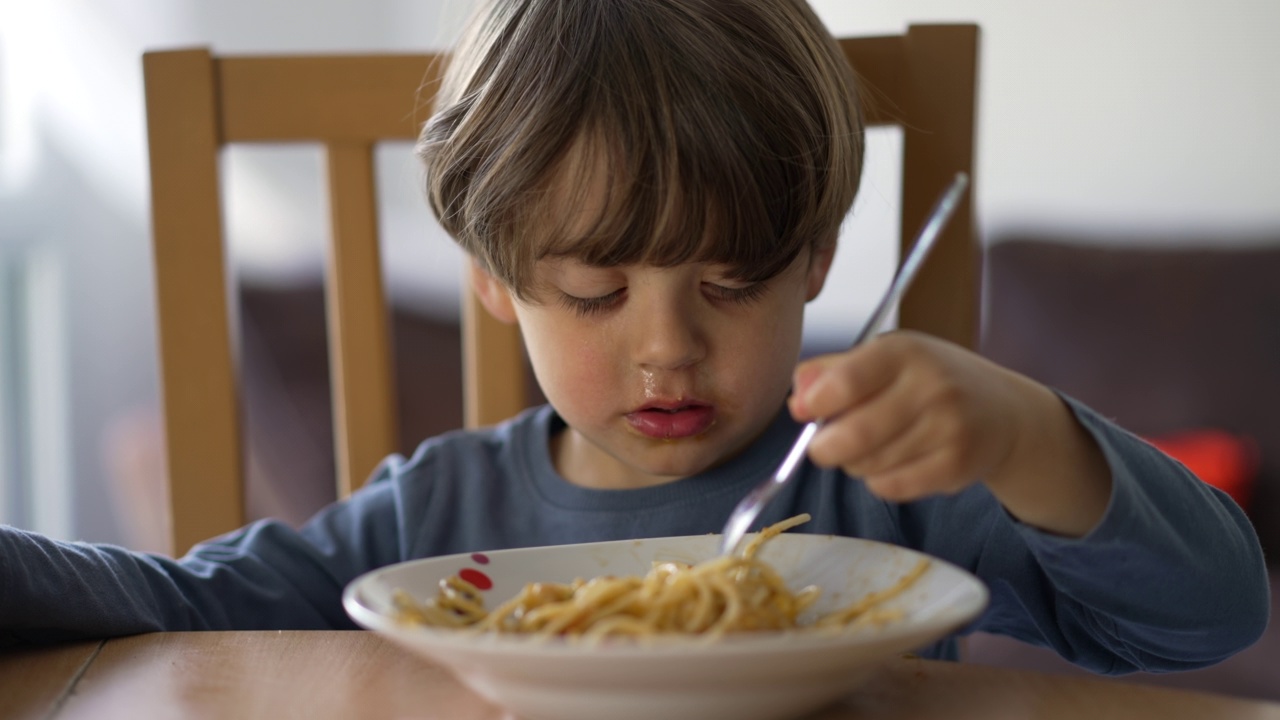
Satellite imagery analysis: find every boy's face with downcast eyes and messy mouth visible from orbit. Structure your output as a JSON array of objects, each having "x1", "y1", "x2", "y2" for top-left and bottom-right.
[{"x1": 477, "y1": 251, "x2": 831, "y2": 488}]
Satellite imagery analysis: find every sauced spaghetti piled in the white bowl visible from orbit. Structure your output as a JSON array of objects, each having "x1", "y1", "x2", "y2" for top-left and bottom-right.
[{"x1": 394, "y1": 514, "x2": 929, "y2": 641}]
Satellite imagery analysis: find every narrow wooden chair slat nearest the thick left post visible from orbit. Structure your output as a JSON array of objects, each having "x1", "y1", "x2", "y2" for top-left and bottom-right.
[{"x1": 325, "y1": 142, "x2": 396, "y2": 497}]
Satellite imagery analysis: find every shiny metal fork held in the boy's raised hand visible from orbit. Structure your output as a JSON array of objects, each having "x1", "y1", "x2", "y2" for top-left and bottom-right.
[{"x1": 719, "y1": 173, "x2": 969, "y2": 555}]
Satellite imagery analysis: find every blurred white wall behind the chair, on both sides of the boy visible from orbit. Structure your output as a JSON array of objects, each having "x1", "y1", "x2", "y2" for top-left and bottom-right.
[{"x1": 0, "y1": 0, "x2": 1280, "y2": 541}]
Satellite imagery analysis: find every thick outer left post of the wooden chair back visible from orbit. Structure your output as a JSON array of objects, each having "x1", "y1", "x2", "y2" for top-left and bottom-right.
[{"x1": 142, "y1": 50, "x2": 244, "y2": 555}]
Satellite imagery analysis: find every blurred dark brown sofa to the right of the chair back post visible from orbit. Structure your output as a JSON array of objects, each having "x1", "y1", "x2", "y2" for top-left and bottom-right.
[{"x1": 966, "y1": 236, "x2": 1280, "y2": 700}]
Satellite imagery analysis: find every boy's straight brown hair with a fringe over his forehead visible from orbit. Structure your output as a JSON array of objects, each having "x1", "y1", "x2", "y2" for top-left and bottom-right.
[{"x1": 417, "y1": 0, "x2": 863, "y2": 297}]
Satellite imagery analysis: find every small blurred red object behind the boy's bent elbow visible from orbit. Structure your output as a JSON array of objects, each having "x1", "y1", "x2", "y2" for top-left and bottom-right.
[{"x1": 1147, "y1": 429, "x2": 1258, "y2": 510}]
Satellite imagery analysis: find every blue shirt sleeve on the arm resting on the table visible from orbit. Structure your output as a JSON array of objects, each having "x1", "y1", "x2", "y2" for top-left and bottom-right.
[{"x1": 0, "y1": 459, "x2": 401, "y2": 643}]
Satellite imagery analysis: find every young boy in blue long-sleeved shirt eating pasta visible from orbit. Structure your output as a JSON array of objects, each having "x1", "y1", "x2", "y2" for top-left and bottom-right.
[{"x1": 0, "y1": 0, "x2": 1268, "y2": 673}]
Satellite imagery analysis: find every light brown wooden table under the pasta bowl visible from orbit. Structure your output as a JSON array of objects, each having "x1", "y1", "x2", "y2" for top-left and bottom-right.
[{"x1": 0, "y1": 632, "x2": 1280, "y2": 720}]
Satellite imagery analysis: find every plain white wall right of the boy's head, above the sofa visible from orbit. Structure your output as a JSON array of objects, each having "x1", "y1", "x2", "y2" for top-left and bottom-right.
[{"x1": 808, "y1": 0, "x2": 1280, "y2": 338}]
